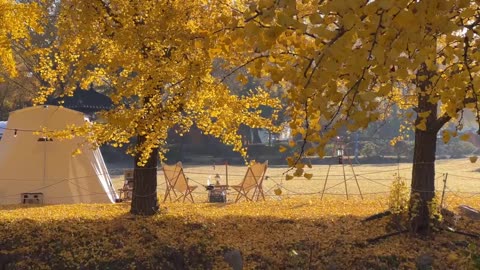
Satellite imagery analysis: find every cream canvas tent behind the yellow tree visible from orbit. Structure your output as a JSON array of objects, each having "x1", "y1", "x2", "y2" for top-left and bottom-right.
[{"x1": 0, "y1": 106, "x2": 117, "y2": 204}]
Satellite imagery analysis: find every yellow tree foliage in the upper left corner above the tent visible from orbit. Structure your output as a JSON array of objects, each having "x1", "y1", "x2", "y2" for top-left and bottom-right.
[{"x1": 0, "y1": 0, "x2": 58, "y2": 119}]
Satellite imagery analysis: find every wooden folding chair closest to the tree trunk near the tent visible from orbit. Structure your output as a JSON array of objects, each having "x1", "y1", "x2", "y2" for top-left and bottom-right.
[{"x1": 162, "y1": 162, "x2": 197, "y2": 203}]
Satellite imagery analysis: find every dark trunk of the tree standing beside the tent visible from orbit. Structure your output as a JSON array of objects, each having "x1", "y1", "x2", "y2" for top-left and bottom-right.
[{"x1": 130, "y1": 135, "x2": 159, "y2": 216}]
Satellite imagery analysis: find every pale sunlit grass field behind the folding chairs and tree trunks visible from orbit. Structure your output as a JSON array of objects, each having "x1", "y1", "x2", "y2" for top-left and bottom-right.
[{"x1": 112, "y1": 158, "x2": 480, "y2": 202}]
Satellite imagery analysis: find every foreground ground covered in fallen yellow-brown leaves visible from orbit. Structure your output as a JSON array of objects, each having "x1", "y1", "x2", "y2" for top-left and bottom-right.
[{"x1": 0, "y1": 196, "x2": 480, "y2": 269}]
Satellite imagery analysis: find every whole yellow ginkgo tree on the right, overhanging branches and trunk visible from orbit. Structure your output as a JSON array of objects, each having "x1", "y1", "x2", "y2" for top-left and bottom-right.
[{"x1": 218, "y1": 0, "x2": 480, "y2": 234}]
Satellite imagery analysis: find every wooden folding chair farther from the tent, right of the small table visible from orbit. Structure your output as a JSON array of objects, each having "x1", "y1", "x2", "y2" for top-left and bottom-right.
[{"x1": 231, "y1": 160, "x2": 268, "y2": 202}]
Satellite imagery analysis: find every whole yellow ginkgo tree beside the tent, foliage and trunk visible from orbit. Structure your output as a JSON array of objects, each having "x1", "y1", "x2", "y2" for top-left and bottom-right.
[{"x1": 36, "y1": 0, "x2": 279, "y2": 215}]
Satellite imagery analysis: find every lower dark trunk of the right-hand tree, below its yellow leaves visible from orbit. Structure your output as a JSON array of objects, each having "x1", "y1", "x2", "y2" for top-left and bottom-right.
[{"x1": 410, "y1": 129, "x2": 437, "y2": 235}]
